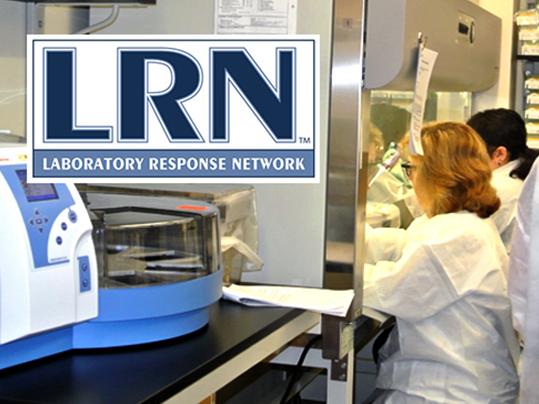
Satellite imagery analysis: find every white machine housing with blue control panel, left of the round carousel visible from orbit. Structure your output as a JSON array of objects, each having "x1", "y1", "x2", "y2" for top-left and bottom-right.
[{"x1": 0, "y1": 147, "x2": 98, "y2": 344}]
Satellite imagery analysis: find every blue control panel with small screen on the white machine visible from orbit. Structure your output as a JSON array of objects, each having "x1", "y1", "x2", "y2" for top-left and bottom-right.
[{"x1": 0, "y1": 164, "x2": 74, "y2": 268}]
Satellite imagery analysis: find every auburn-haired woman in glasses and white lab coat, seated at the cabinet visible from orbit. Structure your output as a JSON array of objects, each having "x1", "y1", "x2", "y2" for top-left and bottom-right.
[{"x1": 363, "y1": 122, "x2": 519, "y2": 404}]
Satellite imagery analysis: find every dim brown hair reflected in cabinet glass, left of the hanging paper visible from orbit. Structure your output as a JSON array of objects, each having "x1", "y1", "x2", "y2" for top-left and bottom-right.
[{"x1": 371, "y1": 103, "x2": 411, "y2": 149}]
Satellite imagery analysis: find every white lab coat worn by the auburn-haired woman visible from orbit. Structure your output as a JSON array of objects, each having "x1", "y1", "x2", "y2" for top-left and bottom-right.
[{"x1": 363, "y1": 212, "x2": 518, "y2": 403}]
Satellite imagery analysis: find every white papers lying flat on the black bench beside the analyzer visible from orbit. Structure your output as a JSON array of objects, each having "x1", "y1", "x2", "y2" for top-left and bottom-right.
[{"x1": 223, "y1": 285, "x2": 354, "y2": 317}]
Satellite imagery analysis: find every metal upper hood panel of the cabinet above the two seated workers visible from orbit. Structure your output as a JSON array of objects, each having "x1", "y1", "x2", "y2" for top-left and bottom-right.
[{"x1": 364, "y1": 0, "x2": 501, "y2": 92}]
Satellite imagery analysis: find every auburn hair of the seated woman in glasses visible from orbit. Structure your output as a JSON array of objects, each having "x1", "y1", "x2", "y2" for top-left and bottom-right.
[{"x1": 413, "y1": 122, "x2": 500, "y2": 218}]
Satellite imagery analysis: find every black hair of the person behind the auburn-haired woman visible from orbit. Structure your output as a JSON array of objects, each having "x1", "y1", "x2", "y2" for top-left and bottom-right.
[{"x1": 466, "y1": 108, "x2": 539, "y2": 180}]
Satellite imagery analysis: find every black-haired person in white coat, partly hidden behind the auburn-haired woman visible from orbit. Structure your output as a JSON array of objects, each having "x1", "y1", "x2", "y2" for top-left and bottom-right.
[{"x1": 467, "y1": 108, "x2": 539, "y2": 252}]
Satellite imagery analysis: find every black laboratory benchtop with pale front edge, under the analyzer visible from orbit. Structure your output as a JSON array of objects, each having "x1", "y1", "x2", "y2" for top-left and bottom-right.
[{"x1": 0, "y1": 300, "x2": 320, "y2": 404}]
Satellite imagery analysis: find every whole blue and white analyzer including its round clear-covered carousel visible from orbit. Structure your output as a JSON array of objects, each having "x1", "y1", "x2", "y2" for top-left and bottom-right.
[{"x1": 0, "y1": 147, "x2": 222, "y2": 369}]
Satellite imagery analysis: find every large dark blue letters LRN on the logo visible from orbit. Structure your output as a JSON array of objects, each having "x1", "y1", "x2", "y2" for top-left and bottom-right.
[{"x1": 44, "y1": 48, "x2": 296, "y2": 143}]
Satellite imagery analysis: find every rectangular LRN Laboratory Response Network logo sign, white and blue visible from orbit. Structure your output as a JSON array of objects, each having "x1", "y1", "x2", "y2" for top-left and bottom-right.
[{"x1": 27, "y1": 35, "x2": 319, "y2": 183}]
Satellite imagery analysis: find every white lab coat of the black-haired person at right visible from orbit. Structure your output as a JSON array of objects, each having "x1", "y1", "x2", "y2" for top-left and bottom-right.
[{"x1": 491, "y1": 160, "x2": 523, "y2": 252}]
